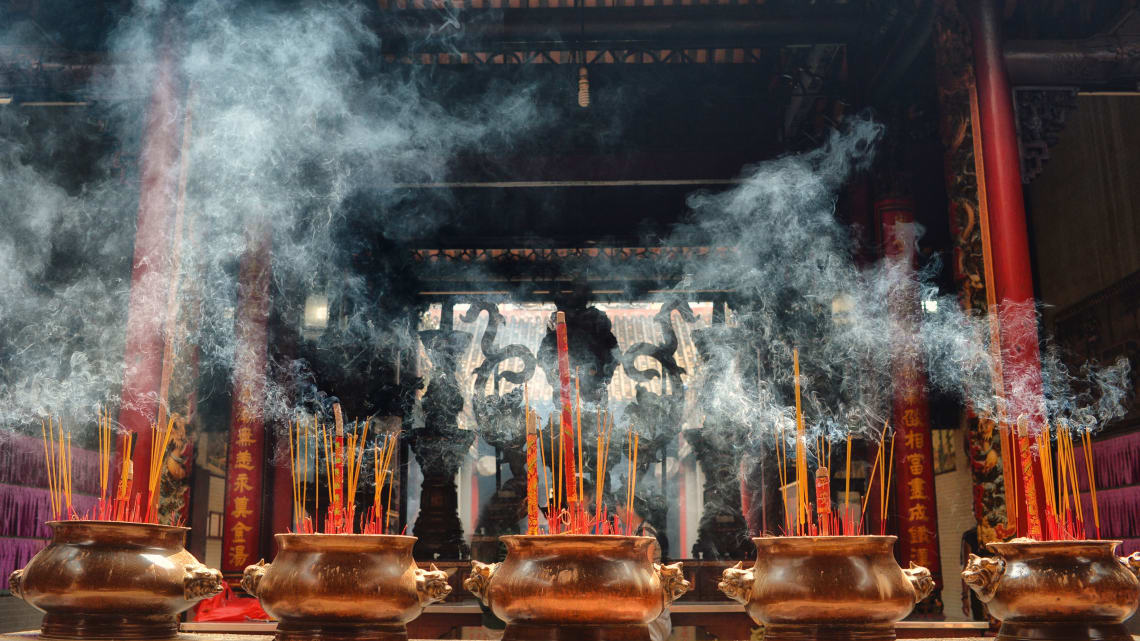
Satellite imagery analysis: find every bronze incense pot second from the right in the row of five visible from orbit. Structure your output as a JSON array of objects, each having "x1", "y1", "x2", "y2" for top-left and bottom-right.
[{"x1": 718, "y1": 536, "x2": 934, "y2": 641}]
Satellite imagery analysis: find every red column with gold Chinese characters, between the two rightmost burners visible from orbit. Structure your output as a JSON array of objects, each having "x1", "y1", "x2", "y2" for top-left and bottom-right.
[{"x1": 876, "y1": 198, "x2": 942, "y2": 590}]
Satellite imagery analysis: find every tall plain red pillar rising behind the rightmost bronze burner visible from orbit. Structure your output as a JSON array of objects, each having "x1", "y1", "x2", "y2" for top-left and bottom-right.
[{"x1": 964, "y1": 0, "x2": 1044, "y2": 538}]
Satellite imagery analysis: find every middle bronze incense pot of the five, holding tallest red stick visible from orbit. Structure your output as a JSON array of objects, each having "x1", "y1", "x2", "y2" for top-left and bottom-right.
[{"x1": 463, "y1": 535, "x2": 690, "y2": 641}]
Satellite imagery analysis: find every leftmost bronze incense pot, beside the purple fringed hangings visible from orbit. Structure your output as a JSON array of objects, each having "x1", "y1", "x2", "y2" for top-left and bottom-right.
[{"x1": 8, "y1": 520, "x2": 222, "y2": 639}]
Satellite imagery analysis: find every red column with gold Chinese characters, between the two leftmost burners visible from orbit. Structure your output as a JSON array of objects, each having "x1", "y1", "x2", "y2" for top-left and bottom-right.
[{"x1": 221, "y1": 226, "x2": 270, "y2": 573}]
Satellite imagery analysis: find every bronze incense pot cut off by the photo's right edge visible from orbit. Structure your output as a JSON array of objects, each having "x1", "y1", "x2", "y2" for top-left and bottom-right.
[{"x1": 962, "y1": 539, "x2": 1140, "y2": 641}]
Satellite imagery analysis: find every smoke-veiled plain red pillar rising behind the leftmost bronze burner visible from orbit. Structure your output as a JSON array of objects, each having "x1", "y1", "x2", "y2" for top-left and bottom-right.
[{"x1": 119, "y1": 48, "x2": 182, "y2": 501}]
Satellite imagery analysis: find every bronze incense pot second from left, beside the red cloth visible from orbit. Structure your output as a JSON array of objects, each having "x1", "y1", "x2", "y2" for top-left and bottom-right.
[{"x1": 242, "y1": 534, "x2": 451, "y2": 641}]
